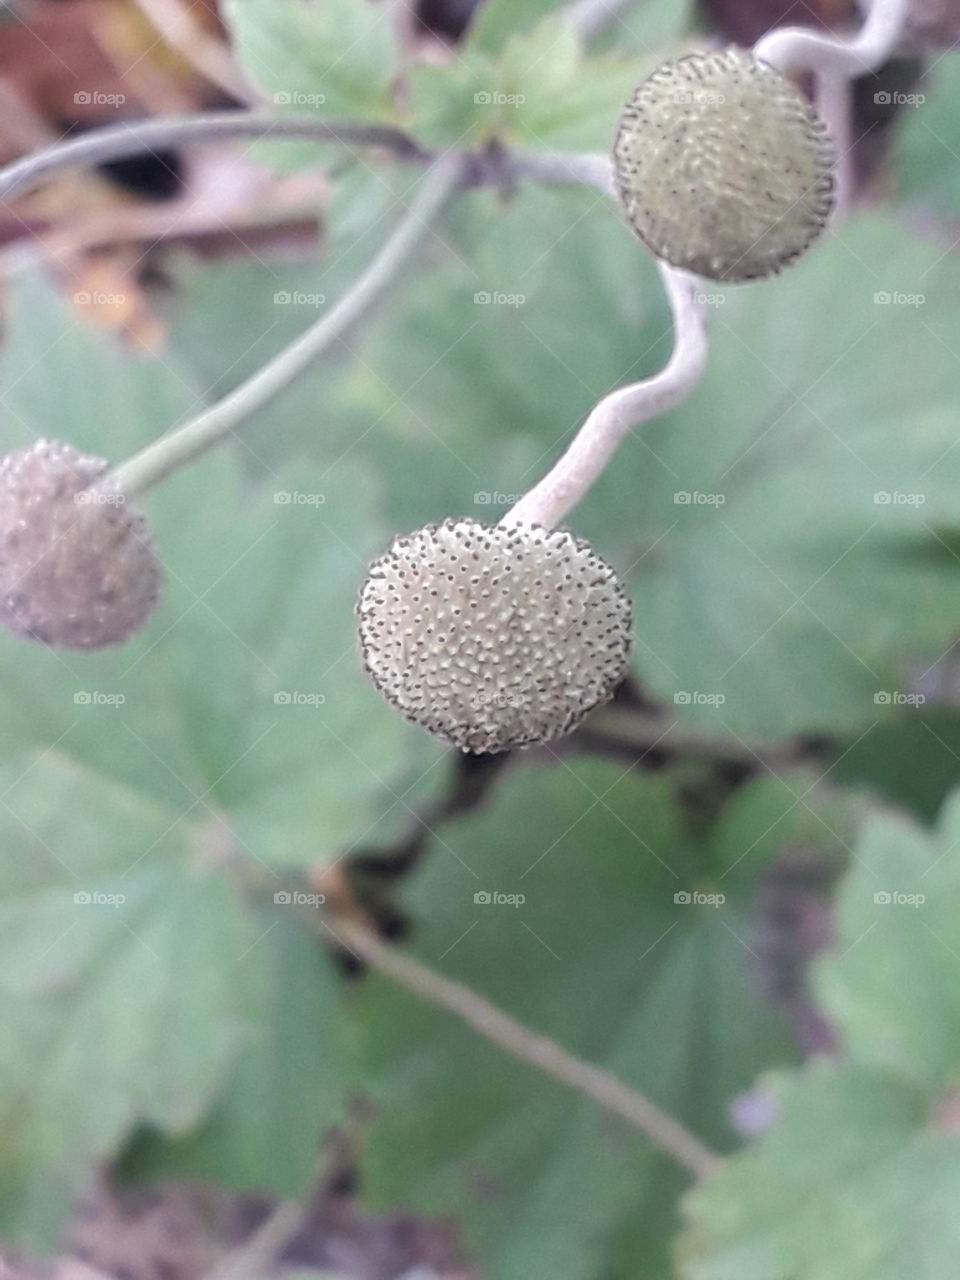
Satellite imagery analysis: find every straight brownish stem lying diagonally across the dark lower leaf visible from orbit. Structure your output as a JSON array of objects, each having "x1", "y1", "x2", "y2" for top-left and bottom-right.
[{"x1": 328, "y1": 919, "x2": 719, "y2": 1178}]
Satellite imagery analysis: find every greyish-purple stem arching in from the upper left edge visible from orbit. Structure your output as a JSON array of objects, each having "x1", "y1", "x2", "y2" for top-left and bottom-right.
[{"x1": 0, "y1": 111, "x2": 430, "y2": 201}]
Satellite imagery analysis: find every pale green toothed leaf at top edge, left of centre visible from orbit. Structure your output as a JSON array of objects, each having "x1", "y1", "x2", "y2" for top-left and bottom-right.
[{"x1": 225, "y1": 0, "x2": 393, "y2": 120}]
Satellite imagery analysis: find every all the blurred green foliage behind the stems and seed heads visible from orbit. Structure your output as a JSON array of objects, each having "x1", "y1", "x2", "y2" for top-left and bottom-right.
[{"x1": 0, "y1": 0, "x2": 960, "y2": 1280}]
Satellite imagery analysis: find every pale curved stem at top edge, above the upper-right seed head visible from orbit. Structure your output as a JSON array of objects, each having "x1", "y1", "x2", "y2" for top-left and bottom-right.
[{"x1": 754, "y1": 0, "x2": 909, "y2": 77}]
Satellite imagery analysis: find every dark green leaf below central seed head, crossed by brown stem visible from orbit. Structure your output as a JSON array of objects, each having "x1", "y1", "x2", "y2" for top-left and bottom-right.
[{"x1": 358, "y1": 760, "x2": 855, "y2": 1280}]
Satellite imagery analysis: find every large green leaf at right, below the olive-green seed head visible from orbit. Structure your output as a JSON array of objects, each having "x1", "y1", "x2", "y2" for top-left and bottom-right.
[{"x1": 611, "y1": 219, "x2": 960, "y2": 735}]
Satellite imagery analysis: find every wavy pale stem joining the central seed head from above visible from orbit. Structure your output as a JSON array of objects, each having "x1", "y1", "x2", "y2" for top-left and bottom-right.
[{"x1": 500, "y1": 262, "x2": 709, "y2": 529}]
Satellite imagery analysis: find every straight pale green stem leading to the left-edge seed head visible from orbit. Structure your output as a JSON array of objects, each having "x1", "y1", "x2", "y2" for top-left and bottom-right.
[{"x1": 111, "y1": 154, "x2": 463, "y2": 494}]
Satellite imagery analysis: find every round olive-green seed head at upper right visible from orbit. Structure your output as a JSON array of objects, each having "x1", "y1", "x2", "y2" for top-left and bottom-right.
[{"x1": 613, "y1": 46, "x2": 833, "y2": 282}]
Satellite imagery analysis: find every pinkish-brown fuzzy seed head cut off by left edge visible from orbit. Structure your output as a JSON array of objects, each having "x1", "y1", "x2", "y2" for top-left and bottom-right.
[{"x1": 0, "y1": 439, "x2": 163, "y2": 649}]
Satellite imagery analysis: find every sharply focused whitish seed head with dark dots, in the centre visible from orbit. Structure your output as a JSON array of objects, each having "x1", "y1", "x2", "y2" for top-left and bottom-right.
[{"x1": 357, "y1": 518, "x2": 631, "y2": 754}]
